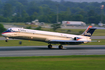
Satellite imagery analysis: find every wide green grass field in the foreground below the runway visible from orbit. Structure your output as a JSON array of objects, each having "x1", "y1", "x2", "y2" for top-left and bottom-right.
[{"x1": 0, "y1": 55, "x2": 105, "y2": 70}]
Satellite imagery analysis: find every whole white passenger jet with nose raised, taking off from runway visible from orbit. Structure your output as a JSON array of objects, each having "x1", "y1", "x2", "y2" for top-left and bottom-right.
[{"x1": 2, "y1": 26, "x2": 96, "y2": 49}]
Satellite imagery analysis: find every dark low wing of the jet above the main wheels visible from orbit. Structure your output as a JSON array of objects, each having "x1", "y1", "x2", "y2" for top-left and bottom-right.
[{"x1": 48, "y1": 40, "x2": 89, "y2": 45}]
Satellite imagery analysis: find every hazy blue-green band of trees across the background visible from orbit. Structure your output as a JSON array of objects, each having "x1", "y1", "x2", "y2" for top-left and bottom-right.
[{"x1": 0, "y1": 0, "x2": 105, "y2": 24}]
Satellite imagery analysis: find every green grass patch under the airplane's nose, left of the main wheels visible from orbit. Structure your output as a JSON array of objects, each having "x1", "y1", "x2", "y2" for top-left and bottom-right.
[{"x1": 0, "y1": 40, "x2": 48, "y2": 46}]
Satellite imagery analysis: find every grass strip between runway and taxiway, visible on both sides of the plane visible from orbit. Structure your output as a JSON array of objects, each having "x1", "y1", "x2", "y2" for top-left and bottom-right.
[{"x1": 0, "y1": 39, "x2": 105, "y2": 46}]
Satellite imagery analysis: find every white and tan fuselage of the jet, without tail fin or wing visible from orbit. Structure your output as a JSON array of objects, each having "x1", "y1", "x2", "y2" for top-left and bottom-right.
[{"x1": 2, "y1": 28, "x2": 91, "y2": 42}]
